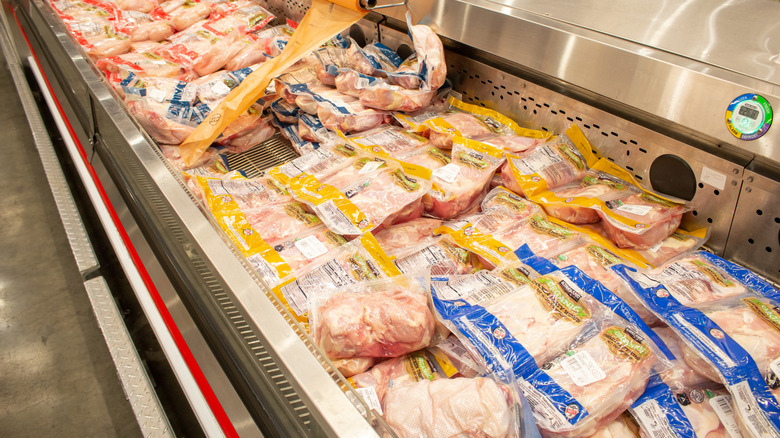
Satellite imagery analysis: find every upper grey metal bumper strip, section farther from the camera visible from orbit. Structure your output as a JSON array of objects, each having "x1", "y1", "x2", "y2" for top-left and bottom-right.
[{"x1": 0, "y1": 6, "x2": 99, "y2": 275}]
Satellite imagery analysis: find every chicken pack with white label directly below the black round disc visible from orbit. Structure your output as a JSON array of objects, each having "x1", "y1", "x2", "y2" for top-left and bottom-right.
[{"x1": 599, "y1": 193, "x2": 687, "y2": 250}]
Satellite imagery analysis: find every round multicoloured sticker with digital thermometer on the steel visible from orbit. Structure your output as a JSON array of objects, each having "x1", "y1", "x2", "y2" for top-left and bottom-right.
[{"x1": 726, "y1": 93, "x2": 773, "y2": 140}]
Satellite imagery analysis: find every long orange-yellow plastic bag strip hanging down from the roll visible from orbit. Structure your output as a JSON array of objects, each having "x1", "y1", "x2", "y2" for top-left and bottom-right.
[{"x1": 180, "y1": 0, "x2": 367, "y2": 166}]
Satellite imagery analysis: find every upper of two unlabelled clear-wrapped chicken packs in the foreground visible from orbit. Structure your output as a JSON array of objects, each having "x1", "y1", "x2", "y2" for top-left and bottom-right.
[{"x1": 312, "y1": 282, "x2": 435, "y2": 359}]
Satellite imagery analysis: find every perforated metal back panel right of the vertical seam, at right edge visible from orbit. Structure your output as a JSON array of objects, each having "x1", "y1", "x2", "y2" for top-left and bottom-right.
[{"x1": 725, "y1": 170, "x2": 780, "y2": 282}]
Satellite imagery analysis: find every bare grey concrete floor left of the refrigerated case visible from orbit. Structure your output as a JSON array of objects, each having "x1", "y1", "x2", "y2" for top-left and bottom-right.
[{"x1": 0, "y1": 52, "x2": 141, "y2": 437}]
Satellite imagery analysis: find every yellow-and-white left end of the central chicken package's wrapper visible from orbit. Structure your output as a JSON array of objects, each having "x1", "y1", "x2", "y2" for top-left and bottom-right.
[{"x1": 290, "y1": 174, "x2": 377, "y2": 236}]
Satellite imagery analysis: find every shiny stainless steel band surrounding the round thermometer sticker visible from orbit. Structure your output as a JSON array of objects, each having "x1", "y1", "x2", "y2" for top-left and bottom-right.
[{"x1": 382, "y1": 0, "x2": 780, "y2": 166}]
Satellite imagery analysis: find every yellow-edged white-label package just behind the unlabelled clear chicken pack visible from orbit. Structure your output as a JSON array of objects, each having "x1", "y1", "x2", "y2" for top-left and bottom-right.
[{"x1": 272, "y1": 233, "x2": 401, "y2": 324}]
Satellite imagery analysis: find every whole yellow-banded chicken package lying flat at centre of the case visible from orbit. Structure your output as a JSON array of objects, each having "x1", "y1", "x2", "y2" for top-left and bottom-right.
[{"x1": 290, "y1": 158, "x2": 430, "y2": 236}]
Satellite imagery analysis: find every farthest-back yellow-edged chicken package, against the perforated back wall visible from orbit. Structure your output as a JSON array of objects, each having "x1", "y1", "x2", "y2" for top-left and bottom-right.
[{"x1": 395, "y1": 96, "x2": 526, "y2": 151}]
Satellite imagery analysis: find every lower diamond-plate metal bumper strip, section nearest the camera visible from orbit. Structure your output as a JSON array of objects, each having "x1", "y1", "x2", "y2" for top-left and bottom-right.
[{"x1": 84, "y1": 277, "x2": 174, "y2": 437}]
